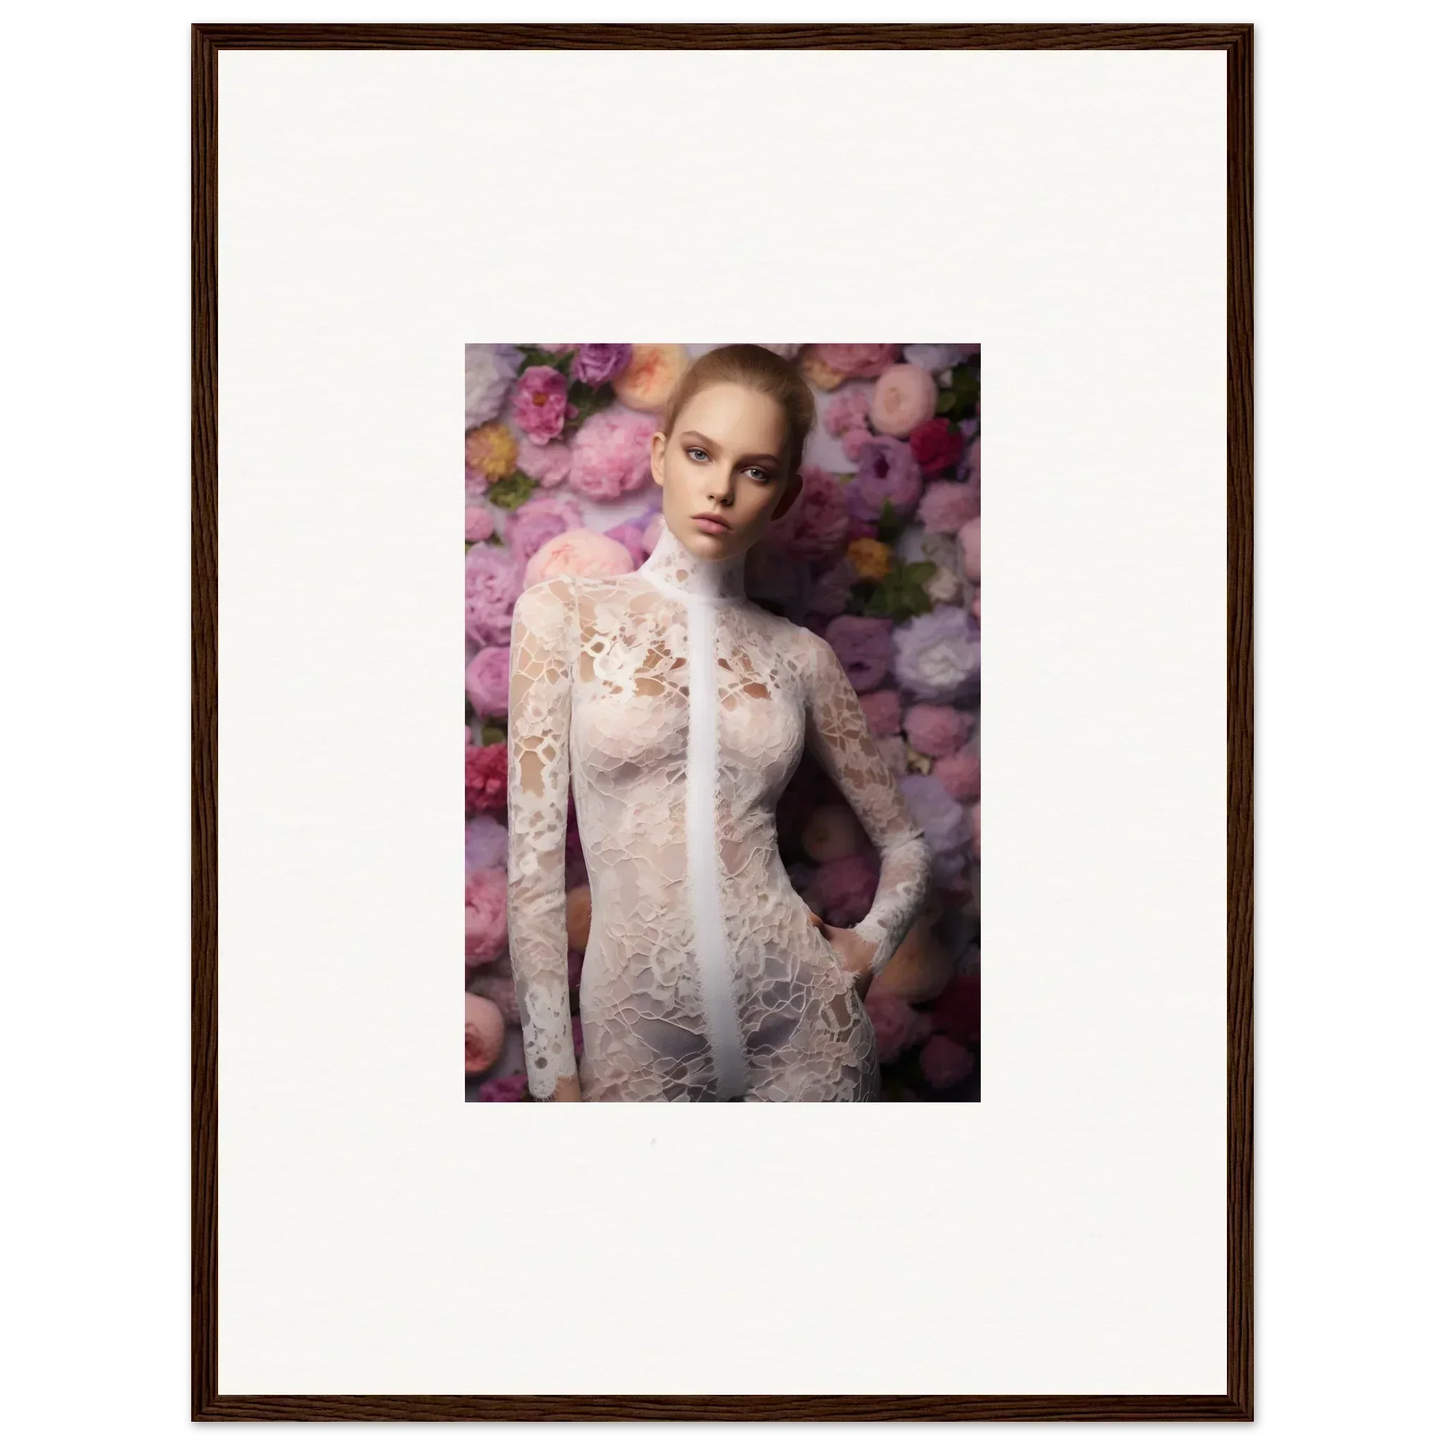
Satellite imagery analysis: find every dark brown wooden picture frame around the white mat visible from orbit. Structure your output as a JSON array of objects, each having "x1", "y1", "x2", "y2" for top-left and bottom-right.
[{"x1": 189, "y1": 22, "x2": 1254, "y2": 1423}]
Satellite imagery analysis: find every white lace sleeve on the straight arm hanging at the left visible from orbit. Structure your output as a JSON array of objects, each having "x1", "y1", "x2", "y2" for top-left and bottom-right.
[{"x1": 507, "y1": 578, "x2": 577, "y2": 1100}]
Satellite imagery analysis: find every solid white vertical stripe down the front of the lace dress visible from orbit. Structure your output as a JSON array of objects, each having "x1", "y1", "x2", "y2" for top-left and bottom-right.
[{"x1": 688, "y1": 597, "x2": 747, "y2": 1100}]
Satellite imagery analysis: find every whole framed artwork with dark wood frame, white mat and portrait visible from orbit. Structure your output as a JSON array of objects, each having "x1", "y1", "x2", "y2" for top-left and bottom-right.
[{"x1": 182, "y1": 17, "x2": 1266, "y2": 1433}]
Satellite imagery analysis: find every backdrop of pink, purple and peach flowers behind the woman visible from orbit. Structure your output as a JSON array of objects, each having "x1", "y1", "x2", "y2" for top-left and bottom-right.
[{"x1": 465, "y1": 342, "x2": 980, "y2": 1103}]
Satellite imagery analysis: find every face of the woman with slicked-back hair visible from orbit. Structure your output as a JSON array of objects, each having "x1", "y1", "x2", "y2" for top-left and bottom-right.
[{"x1": 652, "y1": 381, "x2": 799, "y2": 561}]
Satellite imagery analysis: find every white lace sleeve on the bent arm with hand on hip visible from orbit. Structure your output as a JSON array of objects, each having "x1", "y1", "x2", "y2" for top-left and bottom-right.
[{"x1": 808, "y1": 634, "x2": 932, "y2": 974}]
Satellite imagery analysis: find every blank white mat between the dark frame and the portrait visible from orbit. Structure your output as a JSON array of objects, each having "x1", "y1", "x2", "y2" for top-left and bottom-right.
[{"x1": 220, "y1": 51, "x2": 1225, "y2": 1393}]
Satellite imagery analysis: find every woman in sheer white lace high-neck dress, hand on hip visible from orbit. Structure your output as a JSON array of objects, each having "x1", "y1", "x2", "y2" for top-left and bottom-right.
[{"x1": 507, "y1": 345, "x2": 931, "y2": 1101}]
